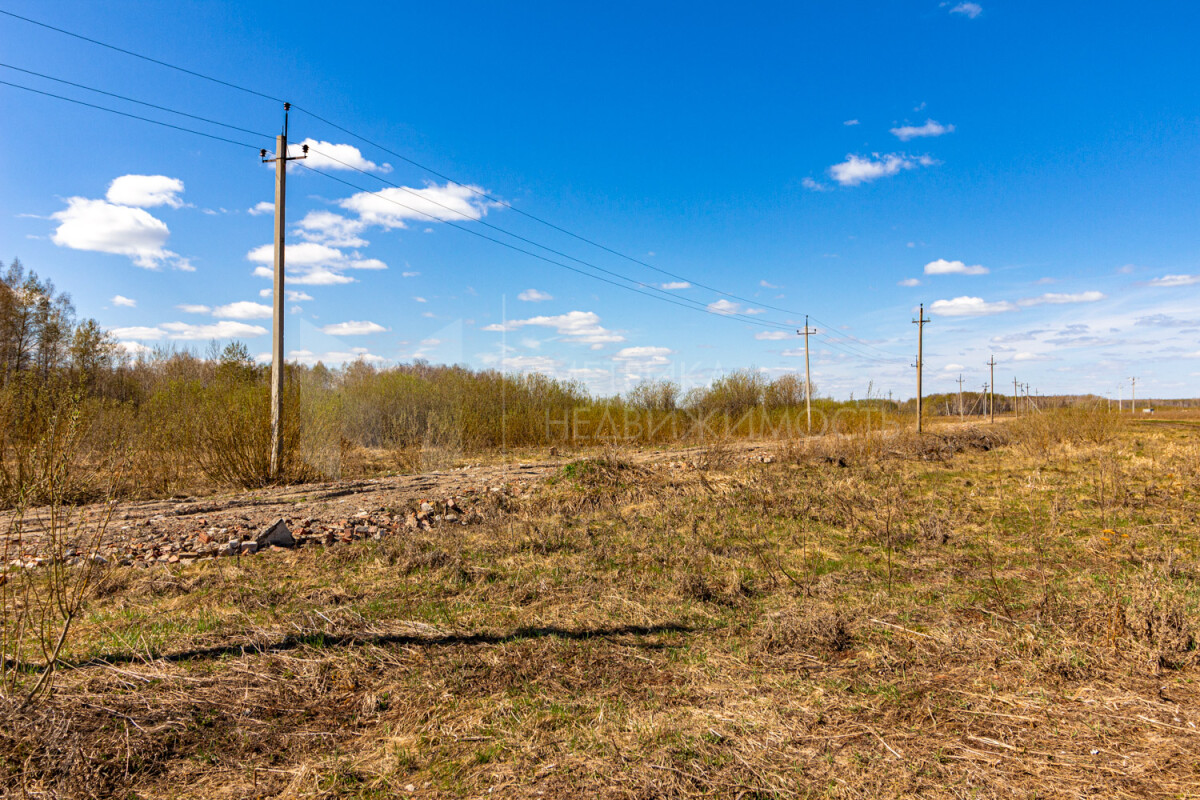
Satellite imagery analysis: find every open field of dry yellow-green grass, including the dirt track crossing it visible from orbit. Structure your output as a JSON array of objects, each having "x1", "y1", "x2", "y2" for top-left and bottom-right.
[{"x1": 0, "y1": 414, "x2": 1200, "y2": 799}]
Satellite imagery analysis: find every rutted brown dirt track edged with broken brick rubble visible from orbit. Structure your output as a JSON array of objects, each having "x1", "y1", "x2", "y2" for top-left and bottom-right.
[{"x1": 0, "y1": 443, "x2": 778, "y2": 569}]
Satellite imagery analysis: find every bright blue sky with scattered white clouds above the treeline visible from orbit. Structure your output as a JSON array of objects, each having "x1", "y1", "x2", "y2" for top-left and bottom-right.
[{"x1": 0, "y1": 0, "x2": 1200, "y2": 397}]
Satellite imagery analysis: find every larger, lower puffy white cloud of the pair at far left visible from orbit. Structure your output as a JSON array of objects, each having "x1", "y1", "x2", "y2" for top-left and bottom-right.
[{"x1": 50, "y1": 197, "x2": 178, "y2": 270}]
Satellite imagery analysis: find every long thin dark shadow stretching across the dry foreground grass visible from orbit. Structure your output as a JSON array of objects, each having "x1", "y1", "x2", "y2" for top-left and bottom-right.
[{"x1": 63, "y1": 624, "x2": 698, "y2": 672}]
